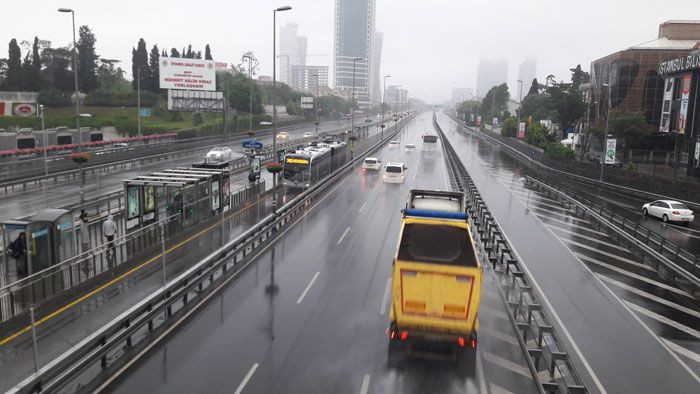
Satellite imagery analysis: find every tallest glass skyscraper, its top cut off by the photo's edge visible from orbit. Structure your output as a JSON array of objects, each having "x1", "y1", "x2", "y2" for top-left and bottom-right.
[{"x1": 333, "y1": 0, "x2": 376, "y2": 108}]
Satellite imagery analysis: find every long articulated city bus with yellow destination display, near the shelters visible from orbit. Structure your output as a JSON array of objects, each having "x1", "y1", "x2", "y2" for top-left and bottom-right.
[{"x1": 283, "y1": 141, "x2": 347, "y2": 189}]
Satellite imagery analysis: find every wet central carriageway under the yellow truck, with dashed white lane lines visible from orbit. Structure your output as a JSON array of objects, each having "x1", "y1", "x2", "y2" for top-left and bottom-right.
[{"x1": 107, "y1": 114, "x2": 534, "y2": 393}]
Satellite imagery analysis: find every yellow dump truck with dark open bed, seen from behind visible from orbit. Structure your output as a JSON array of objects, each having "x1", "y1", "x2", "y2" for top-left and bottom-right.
[{"x1": 387, "y1": 190, "x2": 483, "y2": 359}]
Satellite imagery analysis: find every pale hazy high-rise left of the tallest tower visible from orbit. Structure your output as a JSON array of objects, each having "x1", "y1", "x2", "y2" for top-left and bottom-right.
[{"x1": 277, "y1": 23, "x2": 307, "y2": 89}]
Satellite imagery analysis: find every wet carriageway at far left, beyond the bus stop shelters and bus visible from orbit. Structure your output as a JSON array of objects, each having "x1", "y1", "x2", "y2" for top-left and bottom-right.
[{"x1": 0, "y1": 121, "x2": 393, "y2": 220}]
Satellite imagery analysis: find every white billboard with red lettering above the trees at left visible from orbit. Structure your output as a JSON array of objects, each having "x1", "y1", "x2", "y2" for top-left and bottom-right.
[{"x1": 158, "y1": 57, "x2": 216, "y2": 90}]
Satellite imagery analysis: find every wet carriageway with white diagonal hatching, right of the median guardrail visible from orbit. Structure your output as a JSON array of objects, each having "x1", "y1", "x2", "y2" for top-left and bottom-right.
[{"x1": 438, "y1": 115, "x2": 700, "y2": 393}]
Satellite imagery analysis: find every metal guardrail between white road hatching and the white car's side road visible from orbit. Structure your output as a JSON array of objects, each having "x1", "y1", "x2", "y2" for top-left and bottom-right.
[{"x1": 525, "y1": 176, "x2": 700, "y2": 295}]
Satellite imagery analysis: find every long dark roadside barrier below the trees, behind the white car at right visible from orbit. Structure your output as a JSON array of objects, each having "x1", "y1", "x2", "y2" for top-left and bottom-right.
[{"x1": 450, "y1": 116, "x2": 700, "y2": 210}]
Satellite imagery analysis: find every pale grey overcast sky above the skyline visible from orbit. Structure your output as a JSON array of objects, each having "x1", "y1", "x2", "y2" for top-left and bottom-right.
[{"x1": 0, "y1": 0, "x2": 700, "y2": 102}]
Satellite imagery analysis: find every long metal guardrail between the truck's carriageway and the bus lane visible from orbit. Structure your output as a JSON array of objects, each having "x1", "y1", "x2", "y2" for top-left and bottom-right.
[{"x1": 8, "y1": 114, "x2": 410, "y2": 393}]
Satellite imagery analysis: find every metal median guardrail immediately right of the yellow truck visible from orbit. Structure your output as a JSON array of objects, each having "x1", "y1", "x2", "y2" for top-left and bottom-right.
[{"x1": 433, "y1": 116, "x2": 588, "y2": 393}]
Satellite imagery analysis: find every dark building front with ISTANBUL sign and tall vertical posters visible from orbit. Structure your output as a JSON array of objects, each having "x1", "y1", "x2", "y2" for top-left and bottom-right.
[{"x1": 658, "y1": 45, "x2": 700, "y2": 176}]
